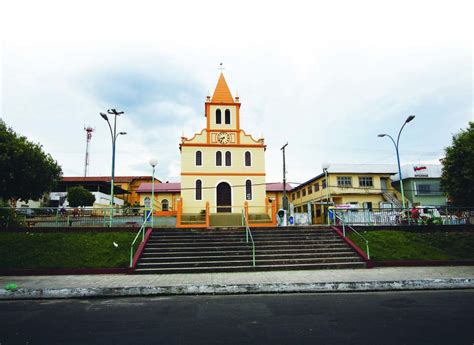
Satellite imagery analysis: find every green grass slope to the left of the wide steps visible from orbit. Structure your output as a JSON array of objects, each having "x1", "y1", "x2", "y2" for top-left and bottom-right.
[{"x1": 0, "y1": 232, "x2": 136, "y2": 269}]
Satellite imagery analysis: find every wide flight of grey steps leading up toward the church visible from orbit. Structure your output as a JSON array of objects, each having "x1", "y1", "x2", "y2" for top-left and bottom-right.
[{"x1": 135, "y1": 227, "x2": 366, "y2": 274}]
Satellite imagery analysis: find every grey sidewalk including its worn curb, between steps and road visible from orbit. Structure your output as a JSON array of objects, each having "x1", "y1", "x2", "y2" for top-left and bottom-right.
[{"x1": 0, "y1": 266, "x2": 474, "y2": 299}]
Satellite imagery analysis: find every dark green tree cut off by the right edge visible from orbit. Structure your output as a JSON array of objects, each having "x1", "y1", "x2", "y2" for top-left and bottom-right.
[{"x1": 441, "y1": 122, "x2": 474, "y2": 206}]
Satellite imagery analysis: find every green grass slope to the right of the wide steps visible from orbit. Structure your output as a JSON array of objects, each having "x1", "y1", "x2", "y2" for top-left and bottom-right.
[{"x1": 348, "y1": 230, "x2": 474, "y2": 261}]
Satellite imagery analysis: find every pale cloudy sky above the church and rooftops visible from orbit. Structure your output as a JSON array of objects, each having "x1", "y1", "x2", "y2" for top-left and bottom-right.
[{"x1": 0, "y1": 0, "x2": 474, "y2": 182}]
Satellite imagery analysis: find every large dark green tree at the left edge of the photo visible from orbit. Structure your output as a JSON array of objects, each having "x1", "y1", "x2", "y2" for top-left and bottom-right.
[{"x1": 0, "y1": 119, "x2": 62, "y2": 201}]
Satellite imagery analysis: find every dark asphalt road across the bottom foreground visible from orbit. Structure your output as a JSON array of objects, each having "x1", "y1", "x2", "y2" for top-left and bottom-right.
[{"x1": 0, "y1": 290, "x2": 474, "y2": 345}]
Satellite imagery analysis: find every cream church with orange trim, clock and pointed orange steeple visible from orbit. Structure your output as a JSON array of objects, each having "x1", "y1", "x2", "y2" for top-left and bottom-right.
[{"x1": 179, "y1": 73, "x2": 271, "y2": 220}]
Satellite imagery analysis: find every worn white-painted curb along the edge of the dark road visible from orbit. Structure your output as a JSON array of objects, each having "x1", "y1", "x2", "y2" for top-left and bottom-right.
[{"x1": 0, "y1": 278, "x2": 474, "y2": 300}]
